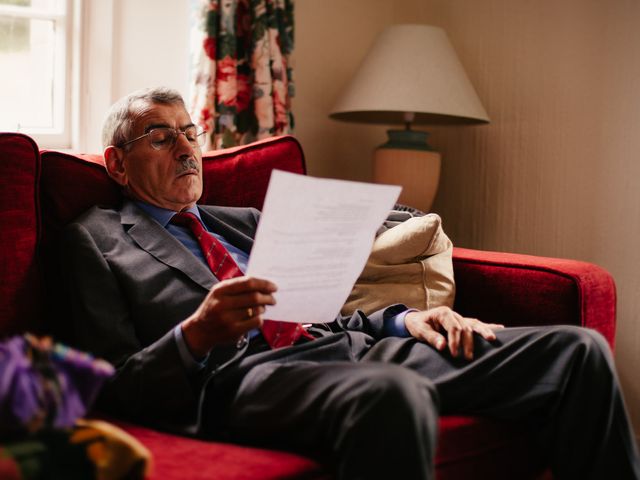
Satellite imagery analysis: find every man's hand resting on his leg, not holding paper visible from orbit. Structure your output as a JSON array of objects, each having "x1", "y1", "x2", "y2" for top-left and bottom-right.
[{"x1": 404, "y1": 307, "x2": 504, "y2": 360}]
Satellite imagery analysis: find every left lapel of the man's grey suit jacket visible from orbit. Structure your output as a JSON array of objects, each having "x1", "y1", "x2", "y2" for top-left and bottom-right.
[{"x1": 121, "y1": 201, "x2": 218, "y2": 291}]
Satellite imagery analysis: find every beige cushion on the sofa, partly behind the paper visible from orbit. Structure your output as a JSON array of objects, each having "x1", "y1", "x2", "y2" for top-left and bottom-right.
[{"x1": 342, "y1": 213, "x2": 455, "y2": 315}]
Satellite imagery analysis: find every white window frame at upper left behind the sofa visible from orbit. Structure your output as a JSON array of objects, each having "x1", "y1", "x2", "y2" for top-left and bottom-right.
[{"x1": 0, "y1": 0, "x2": 80, "y2": 148}]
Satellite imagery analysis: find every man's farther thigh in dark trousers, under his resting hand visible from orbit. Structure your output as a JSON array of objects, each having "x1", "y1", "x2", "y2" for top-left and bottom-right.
[{"x1": 362, "y1": 326, "x2": 608, "y2": 418}]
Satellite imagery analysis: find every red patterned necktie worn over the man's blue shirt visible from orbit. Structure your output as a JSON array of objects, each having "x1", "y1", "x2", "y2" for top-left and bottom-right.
[{"x1": 171, "y1": 212, "x2": 314, "y2": 348}]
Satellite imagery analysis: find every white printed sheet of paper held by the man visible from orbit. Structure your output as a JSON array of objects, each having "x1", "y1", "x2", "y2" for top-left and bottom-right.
[{"x1": 246, "y1": 170, "x2": 401, "y2": 323}]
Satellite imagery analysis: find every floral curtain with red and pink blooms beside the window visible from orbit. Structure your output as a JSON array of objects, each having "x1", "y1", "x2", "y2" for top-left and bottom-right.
[{"x1": 191, "y1": 0, "x2": 293, "y2": 148}]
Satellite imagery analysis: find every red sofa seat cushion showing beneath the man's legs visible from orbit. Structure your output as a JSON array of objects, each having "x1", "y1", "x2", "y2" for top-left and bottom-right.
[{"x1": 111, "y1": 416, "x2": 544, "y2": 480}]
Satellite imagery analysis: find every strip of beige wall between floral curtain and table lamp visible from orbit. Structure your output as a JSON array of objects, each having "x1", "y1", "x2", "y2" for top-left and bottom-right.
[{"x1": 293, "y1": 0, "x2": 393, "y2": 180}]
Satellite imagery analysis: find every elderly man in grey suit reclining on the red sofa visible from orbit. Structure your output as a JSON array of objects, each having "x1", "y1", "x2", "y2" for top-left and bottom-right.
[{"x1": 64, "y1": 88, "x2": 640, "y2": 479}]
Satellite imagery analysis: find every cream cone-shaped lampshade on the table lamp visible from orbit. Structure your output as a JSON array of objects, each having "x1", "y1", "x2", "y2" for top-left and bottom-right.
[{"x1": 329, "y1": 25, "x2": 489, "y2": 125}]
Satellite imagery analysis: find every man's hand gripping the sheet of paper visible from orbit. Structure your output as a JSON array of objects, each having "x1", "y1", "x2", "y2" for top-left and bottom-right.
[{"x1": 182, "y1": 277, "x2": 277, "y2": 357}]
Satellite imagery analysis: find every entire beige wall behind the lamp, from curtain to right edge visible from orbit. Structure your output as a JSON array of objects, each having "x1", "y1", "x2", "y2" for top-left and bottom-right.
[{"x1": 294, "y1": 0, "x2": 640, "y2": 430}]
